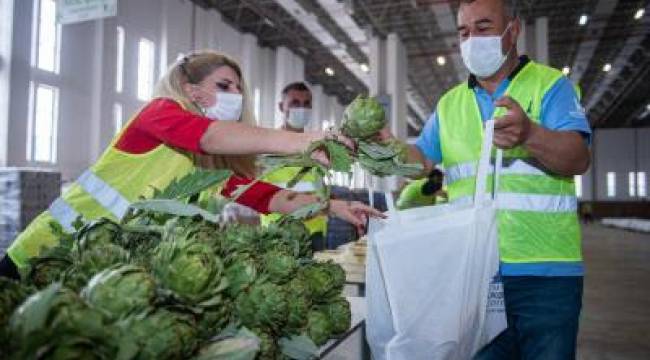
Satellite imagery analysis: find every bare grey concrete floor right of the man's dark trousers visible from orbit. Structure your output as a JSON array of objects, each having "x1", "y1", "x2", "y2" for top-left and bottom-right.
[{"x1": 578, "y1": 225, "x2": 650, "y2": 360}]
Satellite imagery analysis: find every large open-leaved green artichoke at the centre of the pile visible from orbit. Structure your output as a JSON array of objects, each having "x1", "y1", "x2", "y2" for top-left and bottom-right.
[{"x1": 152, "y1": 239, "x2": 228, "y2": 306}]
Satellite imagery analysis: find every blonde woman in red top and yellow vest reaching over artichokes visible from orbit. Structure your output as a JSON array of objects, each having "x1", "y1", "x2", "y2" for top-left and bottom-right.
[{"x1": 0, "y1": 51, "x2": 381, "y2": 276}]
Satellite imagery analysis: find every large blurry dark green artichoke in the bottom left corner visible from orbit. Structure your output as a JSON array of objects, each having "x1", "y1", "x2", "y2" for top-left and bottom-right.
[{"x1": 9, "y1": 283, "x2": 115, "y2": 359}]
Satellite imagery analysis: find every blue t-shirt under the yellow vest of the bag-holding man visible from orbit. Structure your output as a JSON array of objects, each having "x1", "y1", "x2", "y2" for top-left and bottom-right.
[{"x1": 415, "y1": 62, "x2": 591, "y2": 276}]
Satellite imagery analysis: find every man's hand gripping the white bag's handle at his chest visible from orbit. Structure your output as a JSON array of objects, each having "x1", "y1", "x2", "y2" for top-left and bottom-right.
[{"x1": 494, "y1": 96, "x2": 536, "y2": 149}]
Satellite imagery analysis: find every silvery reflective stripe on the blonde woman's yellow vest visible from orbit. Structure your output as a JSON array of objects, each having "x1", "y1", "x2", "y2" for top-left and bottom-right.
[{"x1": 49, "y1": 170, "x2": 131, "y2": 232}]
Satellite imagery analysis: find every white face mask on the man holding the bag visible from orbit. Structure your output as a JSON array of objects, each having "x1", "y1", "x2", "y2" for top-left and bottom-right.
[{"x1": 460, "y1": 23, "x2": 514, "y2": 79}]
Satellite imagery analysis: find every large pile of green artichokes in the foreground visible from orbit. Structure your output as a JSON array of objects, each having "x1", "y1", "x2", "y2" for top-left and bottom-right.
[{"x1": 0, "y1": 170, "x2": 351, "y2": 360}]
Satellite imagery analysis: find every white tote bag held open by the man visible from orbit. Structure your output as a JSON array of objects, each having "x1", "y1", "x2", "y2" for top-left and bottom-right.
[{"x1": 366, "y1": 121, "x2": 506, "y2": 360}]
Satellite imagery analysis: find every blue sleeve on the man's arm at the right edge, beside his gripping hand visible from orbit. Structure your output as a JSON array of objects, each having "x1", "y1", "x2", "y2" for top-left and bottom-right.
[{"x1": 540, "y1": 76, "x2": 591, "y2": 144}]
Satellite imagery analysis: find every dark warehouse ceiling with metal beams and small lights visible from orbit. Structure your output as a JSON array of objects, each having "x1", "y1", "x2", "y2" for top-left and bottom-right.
[{"x1": 193, "y1": 0, "x2": 650, "y2": 135}]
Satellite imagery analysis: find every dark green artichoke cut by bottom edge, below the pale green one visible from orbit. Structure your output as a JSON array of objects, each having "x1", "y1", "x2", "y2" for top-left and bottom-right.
[{"x1": 116, "y1": 309, "x2": 197, "y2": 360}]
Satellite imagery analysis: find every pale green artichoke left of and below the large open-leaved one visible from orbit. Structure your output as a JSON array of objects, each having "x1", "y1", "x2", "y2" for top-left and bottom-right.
[{"x1": 81, "y1": 265, "x2": 156, "y2": 319}]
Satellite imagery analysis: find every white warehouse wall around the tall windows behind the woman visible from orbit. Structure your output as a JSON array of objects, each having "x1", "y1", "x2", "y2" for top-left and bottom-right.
[{"x1": 0, "y1": 0, "x2": 343, "y2": 180}]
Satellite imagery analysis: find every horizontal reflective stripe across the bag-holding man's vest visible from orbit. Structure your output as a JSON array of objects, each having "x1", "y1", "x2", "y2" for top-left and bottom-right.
[{"x1": 453, "y1": 192, "x2": 578, "y2": 213}]
